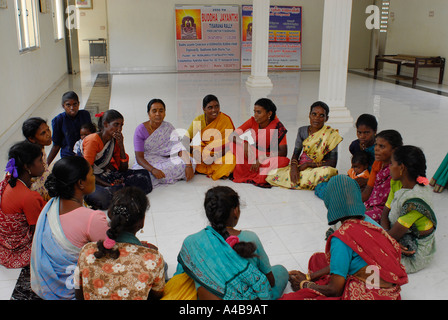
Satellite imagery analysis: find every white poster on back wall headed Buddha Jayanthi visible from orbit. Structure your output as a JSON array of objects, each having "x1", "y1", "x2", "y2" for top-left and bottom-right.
[{"x1": 175, "y1": 5, "x2": 241, "y2": 71}]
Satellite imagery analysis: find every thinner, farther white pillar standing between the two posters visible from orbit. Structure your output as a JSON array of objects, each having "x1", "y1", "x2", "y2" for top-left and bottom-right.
[{"x1": 246, "y1": 0, "x2": 272, "y2": 87}]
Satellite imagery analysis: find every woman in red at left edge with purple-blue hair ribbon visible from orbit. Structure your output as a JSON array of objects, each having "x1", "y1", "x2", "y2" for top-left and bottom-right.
[{"x1": 0, "y1": 141, "x2": 45, "y2": 268}]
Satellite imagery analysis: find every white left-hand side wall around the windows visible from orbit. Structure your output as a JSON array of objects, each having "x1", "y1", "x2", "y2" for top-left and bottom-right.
[{"x1": 0, "y1": 0, "x2": 67, "y2": 141}]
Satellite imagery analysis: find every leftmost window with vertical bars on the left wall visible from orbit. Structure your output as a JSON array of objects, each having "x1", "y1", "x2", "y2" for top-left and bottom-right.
[{"x1": 15, "y1": 0, "x2": 39, "y2": 52}]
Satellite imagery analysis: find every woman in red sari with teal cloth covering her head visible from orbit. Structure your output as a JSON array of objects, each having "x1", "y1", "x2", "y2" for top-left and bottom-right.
[{"x1": 281, "y1": 175, "x2": 408, "y2": 300}]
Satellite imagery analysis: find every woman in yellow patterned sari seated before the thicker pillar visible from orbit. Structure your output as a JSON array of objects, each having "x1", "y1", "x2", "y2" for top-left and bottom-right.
[{"x1": 266, "y1": 101, "x2": 342, "y2": 190}]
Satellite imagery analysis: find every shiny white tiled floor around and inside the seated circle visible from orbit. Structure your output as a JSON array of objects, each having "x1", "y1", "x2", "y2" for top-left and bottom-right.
[{"x1": 0, "y1": 59, "x2": 448, "y2": 300}]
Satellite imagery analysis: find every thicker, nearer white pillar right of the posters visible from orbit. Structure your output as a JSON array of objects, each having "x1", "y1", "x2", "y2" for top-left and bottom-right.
[{"x1": 319, "y1": 0, "x2": 353, "y2": 123}]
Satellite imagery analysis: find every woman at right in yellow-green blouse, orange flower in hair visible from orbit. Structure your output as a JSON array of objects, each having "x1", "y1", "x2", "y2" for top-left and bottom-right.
[{"x1": 383, "y1": 146, "x2": 437, "y2": 273}]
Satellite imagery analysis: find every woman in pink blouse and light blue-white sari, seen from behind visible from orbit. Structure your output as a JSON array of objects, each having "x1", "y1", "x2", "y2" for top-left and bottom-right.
[{"x1": 30, "y1": 156, "x2": 109, "y2": 300}]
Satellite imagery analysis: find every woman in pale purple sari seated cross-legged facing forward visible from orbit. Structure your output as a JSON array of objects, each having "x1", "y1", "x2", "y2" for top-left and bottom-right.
[{"x1": 133, "y1": 99, "x2": 194, "y2": 187}]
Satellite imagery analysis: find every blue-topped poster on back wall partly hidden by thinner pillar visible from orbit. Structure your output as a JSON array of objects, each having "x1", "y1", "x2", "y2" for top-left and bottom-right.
[{"x1": 241, "y1": 5, "x2": 302, "y2": 70}]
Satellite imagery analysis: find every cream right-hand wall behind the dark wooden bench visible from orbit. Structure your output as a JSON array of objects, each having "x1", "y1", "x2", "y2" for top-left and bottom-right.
[{"x1": 384, "y1": 0, "x2": 448, "y2": 84}]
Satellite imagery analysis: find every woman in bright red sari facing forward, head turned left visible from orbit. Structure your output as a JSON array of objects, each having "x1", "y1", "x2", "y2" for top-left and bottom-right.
[{"x1": 229, "y1": 98, "x2": 289, "y2": 188}]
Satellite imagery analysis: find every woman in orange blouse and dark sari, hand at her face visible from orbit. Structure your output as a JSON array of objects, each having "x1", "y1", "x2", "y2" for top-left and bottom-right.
[{"x1": 82, "y1": 109, "x2": 152, "y2": 210}]
